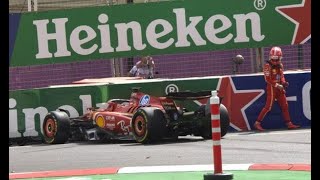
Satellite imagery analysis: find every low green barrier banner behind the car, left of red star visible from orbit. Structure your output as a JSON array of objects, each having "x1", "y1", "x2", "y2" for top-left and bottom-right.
[{"x1": 9, "y1": 77, "x2": 219, "y2": 138}]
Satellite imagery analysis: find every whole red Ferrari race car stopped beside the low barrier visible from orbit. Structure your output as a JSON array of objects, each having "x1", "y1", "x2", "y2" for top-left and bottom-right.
[{"x1": 42, "y1": 88, "x2": 230, "y2": 144}]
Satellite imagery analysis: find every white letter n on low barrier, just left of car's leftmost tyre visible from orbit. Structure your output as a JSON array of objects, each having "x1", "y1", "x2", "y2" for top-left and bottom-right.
[{"x1": 22, "y1": 107, "x2": 48, "y2": 136}]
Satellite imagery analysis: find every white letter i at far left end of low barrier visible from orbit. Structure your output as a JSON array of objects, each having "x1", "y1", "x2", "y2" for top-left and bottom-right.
[{"x1": 9, "y1": 98, "x2": 21, "y2": 138}]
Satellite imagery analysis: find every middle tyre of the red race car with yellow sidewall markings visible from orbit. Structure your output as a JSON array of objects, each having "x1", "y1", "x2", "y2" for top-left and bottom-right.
[{"x1": 131, "y1": 107, "x2": 167, "y2": 144}]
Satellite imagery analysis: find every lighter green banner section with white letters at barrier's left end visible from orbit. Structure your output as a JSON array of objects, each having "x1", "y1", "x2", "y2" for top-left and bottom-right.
[{"x1": 9, "y1": 86, "x2": 108, "y2": 137}]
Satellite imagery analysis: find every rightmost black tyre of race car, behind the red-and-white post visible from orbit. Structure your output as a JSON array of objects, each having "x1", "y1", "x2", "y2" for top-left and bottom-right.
[{"x1": 200, "y1": 103, "x2": 230, "y2": 139}]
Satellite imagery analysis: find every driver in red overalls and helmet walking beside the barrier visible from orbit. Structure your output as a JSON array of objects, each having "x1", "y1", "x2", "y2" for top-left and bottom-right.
[{"x1": 254, "y1": 47, "x2": 300, "y2": 131}]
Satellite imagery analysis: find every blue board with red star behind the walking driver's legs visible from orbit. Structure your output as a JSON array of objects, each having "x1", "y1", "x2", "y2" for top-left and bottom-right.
[{"x1": 217, "y1": 72, "x2": 311, "y2": 131}]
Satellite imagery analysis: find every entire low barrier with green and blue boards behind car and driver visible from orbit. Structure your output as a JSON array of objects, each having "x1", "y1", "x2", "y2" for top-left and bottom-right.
[{"x1": 9, "y1": 71, "x2": 311, "y2": 138}]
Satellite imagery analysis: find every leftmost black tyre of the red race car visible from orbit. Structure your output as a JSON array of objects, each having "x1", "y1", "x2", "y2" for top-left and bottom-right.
[{"x1": 42, "y1": 111, "x2": 70, "y2": 144}]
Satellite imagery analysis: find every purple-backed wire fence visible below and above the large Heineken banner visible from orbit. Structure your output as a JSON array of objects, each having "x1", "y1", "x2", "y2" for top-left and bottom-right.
[{"x1": 9, "y1": 0, "x2": 311, "y2": 90}]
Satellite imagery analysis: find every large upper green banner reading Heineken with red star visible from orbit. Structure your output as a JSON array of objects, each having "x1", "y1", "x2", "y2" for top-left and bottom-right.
[{"x1": 10, "y1": 0, "x2": 311, "y2": 66}]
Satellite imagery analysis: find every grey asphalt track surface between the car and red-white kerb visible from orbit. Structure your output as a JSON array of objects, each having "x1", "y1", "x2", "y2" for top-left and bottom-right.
[{"x1": 9, "y1": 128, "x2": 311, "y2": 173}]
